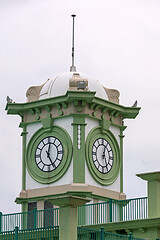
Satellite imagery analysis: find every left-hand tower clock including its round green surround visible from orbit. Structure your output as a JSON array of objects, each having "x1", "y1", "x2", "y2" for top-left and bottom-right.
[{"x1": 26, "y1": 126, "x2": 72, "y2": 184}]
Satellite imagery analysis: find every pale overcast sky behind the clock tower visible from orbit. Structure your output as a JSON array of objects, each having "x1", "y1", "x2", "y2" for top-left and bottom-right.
[{"x1": 0, "y1": 0, "x2": 160, "y2": 213}]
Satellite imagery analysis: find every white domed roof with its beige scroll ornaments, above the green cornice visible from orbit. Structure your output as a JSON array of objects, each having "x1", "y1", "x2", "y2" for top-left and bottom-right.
[{"x1": 26, "y1": 72, "x2": 120, "y2": 104}]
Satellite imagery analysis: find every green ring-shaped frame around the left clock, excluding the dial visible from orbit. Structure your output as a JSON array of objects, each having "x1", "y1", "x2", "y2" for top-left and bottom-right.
[{"x1": 26, "y1": 126, "x2": 72, "y2": 184}]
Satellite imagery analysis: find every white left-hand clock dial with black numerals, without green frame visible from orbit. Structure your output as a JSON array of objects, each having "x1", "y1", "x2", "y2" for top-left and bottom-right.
[{"x1": 35, "y1": 136, "x2": 63, "y2": 172}]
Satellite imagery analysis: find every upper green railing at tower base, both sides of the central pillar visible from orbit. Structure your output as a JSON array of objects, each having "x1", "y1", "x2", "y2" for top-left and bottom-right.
[{"x1": 0, "y1": 197, "x2": 148, "y2": 232}]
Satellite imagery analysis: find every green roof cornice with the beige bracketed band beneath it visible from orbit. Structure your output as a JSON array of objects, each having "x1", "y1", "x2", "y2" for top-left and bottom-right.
[{"x1": 6, "y1": 91, "x2": 140, "y2": 125}]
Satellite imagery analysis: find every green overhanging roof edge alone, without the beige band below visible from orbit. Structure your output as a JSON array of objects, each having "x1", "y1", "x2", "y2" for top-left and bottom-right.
[{"x1": 6, "y1": 91, "x2": 140, "y2": 120}]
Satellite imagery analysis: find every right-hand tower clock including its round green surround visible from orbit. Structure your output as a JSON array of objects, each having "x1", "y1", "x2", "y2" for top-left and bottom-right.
[{"x1": 86, "y1": 127, "x2": 121, "y2": 186}]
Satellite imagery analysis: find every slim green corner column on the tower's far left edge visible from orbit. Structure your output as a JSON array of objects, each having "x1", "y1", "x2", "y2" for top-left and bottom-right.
[{"x1": 21, "y1": 124, "x2": 27, "y2": 190}]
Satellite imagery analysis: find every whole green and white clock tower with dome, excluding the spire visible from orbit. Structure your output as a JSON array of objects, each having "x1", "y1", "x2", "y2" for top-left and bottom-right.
[{"x1": 6, "y1": 71, "x2": 140, "y2": 211}]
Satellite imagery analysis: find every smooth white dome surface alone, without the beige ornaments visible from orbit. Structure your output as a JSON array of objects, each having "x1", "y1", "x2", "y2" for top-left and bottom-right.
[{"x1": 39, "y1": 72, "x2": 108, "y2": 100}]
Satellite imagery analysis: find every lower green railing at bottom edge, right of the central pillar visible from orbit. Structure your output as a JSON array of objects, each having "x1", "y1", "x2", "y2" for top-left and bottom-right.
[{"x1": 77, "y1": 227, "x2": 144, "y2": 240}]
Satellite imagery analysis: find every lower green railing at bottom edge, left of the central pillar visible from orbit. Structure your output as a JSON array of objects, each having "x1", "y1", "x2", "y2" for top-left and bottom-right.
[{"x1": 0, "y1": 227, "x2": 59, "y2": 240}]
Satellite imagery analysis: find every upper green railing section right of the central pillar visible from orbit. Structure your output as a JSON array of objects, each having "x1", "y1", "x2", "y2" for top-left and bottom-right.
[{"x1": 78, "y1": 197, "x2": 148, "y2": 226}]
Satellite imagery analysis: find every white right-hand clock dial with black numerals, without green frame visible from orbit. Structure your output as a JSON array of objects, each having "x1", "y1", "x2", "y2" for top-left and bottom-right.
[{"x1": 92, "y1": 138, "x2": 114, "y2": 174}]
